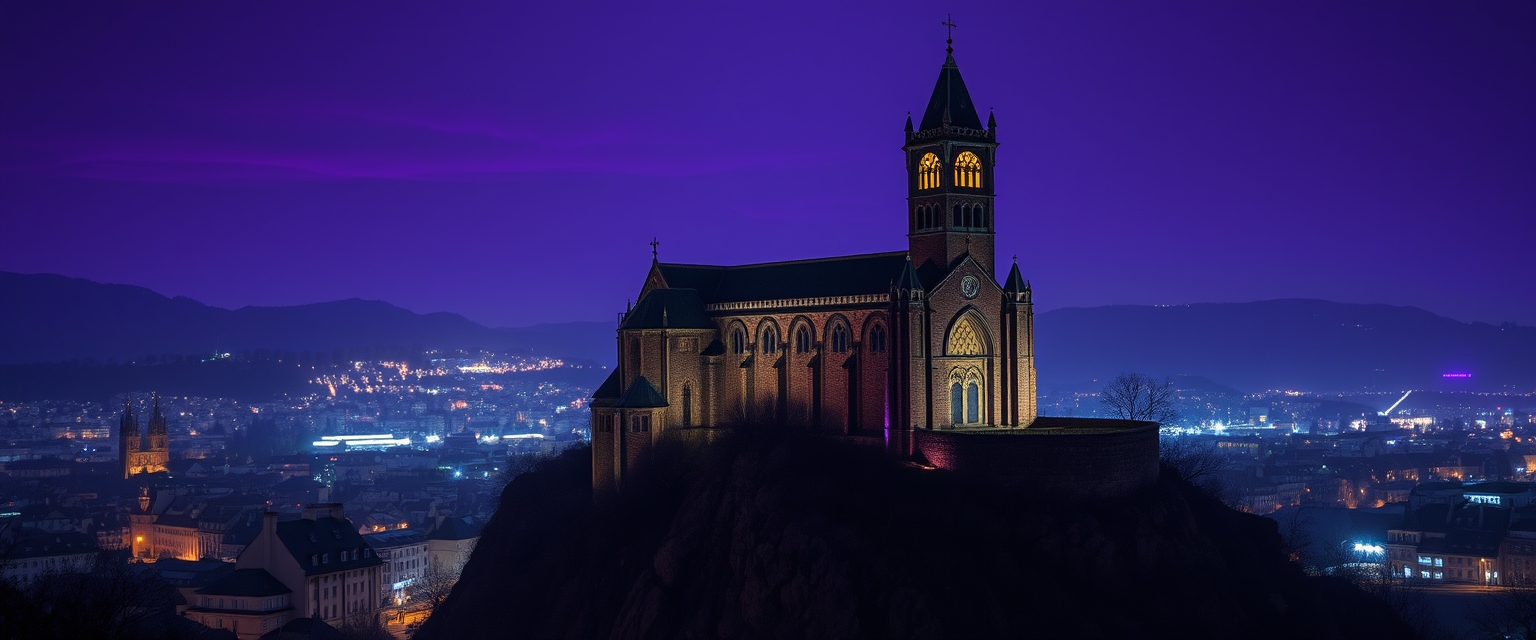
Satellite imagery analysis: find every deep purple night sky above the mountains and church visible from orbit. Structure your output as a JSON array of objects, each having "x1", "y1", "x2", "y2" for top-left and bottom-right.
[{"x1": 0, "y1": 0, "x2": 1536, "y2": 325}]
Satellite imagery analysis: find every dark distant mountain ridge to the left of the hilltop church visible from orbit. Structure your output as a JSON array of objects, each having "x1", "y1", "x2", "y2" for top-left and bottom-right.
[{"x1": 0, "y1": 272, "x2": 614, "y2": 364}]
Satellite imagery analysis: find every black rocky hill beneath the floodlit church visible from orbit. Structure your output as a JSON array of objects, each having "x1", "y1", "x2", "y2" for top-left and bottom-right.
[{"x1": 418, "y1": 434, "x2": 1410, "y2": 640}]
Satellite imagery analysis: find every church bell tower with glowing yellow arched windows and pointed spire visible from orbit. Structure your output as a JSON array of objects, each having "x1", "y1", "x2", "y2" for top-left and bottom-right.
[{"x1": 902, "y1": 31, "x2": 997, "y2": 279}]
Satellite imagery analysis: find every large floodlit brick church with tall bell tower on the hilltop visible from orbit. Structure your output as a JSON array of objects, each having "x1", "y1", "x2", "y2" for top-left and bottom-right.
[{"x1": 591, "y1": 41, "x2": 1035, "y2": 490}]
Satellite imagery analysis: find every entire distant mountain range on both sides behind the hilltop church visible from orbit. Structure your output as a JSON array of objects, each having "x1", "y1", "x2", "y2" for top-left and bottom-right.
[{"x1": 0, "y1": 272, "x2": 1536, "y2": 393}]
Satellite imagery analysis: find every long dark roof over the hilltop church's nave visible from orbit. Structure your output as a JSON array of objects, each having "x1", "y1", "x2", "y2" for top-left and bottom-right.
[{"x1": 659, "y1": 252, "x2": 906, "y2": 302}]
